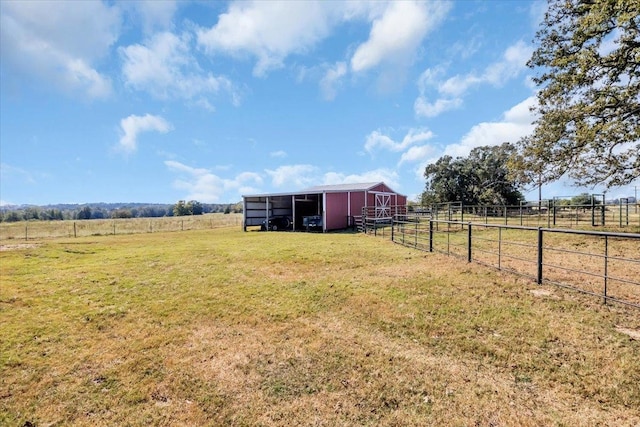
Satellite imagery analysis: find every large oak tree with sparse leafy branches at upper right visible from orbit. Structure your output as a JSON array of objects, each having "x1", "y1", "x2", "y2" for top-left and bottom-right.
[{"x1": 515, "y1": 0, "x2": 640, "y2": 188}]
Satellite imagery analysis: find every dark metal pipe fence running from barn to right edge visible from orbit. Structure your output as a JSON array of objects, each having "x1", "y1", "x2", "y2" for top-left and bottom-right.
[{"x1": 387, "y1": 215, "x2": 640, "y2": 308}]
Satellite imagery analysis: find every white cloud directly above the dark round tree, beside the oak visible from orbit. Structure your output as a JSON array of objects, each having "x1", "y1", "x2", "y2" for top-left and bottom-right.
[{"x1": 444, "y1": 96, "x2": 536, "y2": 157}]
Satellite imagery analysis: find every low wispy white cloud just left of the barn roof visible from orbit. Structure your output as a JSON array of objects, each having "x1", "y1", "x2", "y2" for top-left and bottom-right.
[{"x1": 164, "y1": 160, "x2": 262, "y2": 203}]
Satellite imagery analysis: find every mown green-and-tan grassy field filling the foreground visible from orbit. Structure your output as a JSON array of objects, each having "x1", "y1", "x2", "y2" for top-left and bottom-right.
[{"x1": 0, "y1": 227, "x2": 640, "y2": 426}]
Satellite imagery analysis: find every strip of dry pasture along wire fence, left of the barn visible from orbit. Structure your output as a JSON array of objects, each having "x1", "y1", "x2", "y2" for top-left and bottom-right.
[{"x1": 0, "y1": 213, "x2": 242, "y2": 241}]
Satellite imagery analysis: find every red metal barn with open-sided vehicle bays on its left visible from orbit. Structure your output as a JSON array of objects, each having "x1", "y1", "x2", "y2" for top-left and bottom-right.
[{"x1": 243, "y1": 182, "x2": 407, "y2": 231}]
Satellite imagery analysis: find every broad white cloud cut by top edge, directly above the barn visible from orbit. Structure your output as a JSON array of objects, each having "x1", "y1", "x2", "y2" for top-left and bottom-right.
[{"x1": 198, "y1": 1, "x2": 336, "y2": 76}]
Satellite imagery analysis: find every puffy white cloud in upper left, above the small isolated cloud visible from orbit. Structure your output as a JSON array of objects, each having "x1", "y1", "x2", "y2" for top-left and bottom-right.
[{"x1": 120, "y1": 32, "x2": 237, "y2": 105}]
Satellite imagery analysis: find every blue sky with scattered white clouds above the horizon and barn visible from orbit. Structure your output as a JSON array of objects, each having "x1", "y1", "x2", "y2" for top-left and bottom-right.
[{"x1": 0, "y1": 0, "x2": 634, "y2": 204}]
